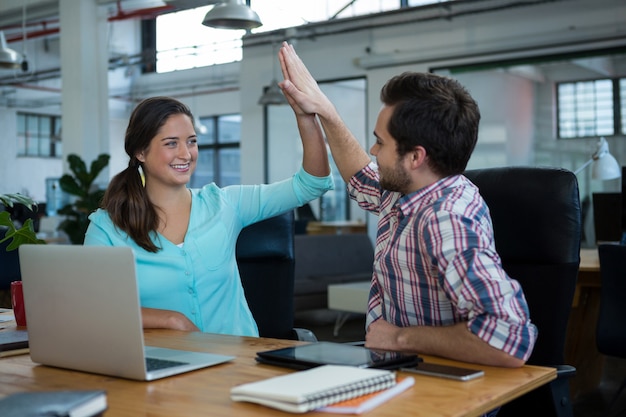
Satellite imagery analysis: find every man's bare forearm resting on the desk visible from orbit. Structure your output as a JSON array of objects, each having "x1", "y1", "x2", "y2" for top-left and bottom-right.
[{"x1": 365, "y1": 319, "x2": 525, "y2": 368}]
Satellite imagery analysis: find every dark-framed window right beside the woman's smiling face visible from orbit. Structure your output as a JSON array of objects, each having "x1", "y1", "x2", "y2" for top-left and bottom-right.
[{"x1": 190, "y1": 114, "x2": 241, "y2": 188}]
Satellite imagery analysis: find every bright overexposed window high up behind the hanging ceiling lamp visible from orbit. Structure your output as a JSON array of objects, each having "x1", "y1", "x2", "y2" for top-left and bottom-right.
[{"x1": 156, "y1": 0, "x2": 448, "y2": 72}]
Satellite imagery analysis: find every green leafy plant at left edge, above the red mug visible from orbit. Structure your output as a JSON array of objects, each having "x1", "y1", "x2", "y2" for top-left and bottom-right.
[{"x1": 0, "y1": 194, "x2": 46, "y2": 251}]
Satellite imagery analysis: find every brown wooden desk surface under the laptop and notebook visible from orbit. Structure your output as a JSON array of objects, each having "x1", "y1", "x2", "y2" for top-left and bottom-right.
[{"x1": 0, "y1": 327, "x2": 556, "y2": 417}]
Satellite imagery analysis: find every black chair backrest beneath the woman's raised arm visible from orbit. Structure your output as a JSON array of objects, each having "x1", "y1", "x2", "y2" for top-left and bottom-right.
[{"x1": 236, "y1": 211, "x2": 295, "y2": 339}]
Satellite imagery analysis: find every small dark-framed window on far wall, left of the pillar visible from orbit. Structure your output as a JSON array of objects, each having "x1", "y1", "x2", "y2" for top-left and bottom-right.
[{"x1": 17, "y1": 113, "x2": 63, "y2": 157}]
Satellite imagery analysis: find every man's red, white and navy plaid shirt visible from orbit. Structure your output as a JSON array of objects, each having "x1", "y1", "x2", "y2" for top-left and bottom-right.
[{"x1": 348, "y1": 163, "x2": 537, "y2": 360}]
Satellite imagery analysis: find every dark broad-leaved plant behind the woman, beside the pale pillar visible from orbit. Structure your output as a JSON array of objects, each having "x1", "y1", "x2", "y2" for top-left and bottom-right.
[{"x1": 58, "y1": 154, "x2": 110, "y2": 245}]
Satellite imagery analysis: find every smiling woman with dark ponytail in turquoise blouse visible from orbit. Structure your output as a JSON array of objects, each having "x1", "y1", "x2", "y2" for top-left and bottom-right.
[{"x1": 85, "y1": 97, "x2": 332, "y2": 336}]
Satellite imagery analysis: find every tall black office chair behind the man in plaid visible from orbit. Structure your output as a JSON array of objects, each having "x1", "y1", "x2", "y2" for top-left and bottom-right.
[{"x1": 465, "y1": 167, "x2": 581, "y2": 417}]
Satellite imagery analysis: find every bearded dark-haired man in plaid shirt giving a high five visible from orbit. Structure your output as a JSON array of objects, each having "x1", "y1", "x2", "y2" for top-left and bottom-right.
[{"x1": 279, "y1": 43, "x2": 537, "y2": 367}]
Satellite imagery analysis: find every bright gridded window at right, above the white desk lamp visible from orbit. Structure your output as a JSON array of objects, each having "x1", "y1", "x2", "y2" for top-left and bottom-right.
[{"x1": 557, "y1": 79, "x2": 624, "y2": 138}]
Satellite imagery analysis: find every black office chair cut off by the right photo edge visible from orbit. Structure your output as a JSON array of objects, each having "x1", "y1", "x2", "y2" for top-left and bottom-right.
[{"x1": 596, "y1": 244, "x2": 626, "y2": 415}]
